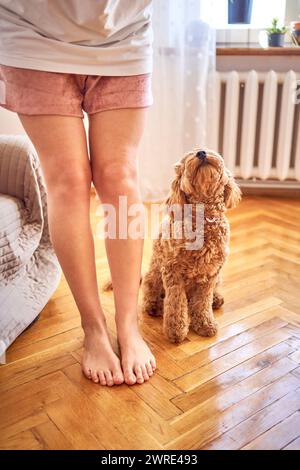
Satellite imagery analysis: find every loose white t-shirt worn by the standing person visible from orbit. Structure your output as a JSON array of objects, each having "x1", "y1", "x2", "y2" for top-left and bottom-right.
[{"x1": 0, "y1": 0, "x2": 152, "y2": 76}]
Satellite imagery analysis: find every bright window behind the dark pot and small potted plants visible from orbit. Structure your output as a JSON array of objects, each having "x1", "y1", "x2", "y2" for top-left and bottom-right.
[{"x1": 202, "y1": 0, "x2": 286, "y2": 29}]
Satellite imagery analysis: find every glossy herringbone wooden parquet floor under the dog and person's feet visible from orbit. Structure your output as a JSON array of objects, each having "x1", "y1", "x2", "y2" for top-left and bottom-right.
[{"x1": 0, "y1": 198, "x2": 300, "y2": 449}]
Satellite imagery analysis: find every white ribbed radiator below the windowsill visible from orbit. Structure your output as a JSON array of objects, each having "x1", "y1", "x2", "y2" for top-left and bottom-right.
[{"x1": 209, "y1": 70, "x2": 300, "y2": 186}]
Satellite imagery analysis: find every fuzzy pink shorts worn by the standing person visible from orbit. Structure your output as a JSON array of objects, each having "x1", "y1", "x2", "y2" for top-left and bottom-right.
[{"x1": 0, "y1": 65, "x2": 153, "y2": 117}]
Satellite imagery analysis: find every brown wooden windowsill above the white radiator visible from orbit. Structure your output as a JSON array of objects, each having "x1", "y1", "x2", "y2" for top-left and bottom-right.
[{"x1": 217, "y1": 43, "x2": 300, "y2": 56}]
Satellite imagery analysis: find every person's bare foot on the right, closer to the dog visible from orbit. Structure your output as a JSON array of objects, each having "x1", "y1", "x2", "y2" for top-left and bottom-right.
[{"x1": 118, "y1": 324, "x2": 156, "y2": 385}]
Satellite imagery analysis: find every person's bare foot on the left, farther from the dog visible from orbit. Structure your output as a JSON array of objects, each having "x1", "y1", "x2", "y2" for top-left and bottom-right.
[{"x1": 82, "y1": 325, "x2": 124, "y2": 387}]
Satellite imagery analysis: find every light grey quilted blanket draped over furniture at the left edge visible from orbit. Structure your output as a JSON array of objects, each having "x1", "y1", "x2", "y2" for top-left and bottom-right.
[{"x1": 0, "y1": 135, "x2": 61, "y2": 357}]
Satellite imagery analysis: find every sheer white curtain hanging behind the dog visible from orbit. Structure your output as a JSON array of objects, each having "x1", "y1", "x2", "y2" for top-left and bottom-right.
[{"x1": 140, "y1": 0, "x2": 216, "y2": 200}]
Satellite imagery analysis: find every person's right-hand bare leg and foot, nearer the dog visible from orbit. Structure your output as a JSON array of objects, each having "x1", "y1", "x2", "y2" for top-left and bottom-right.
[{"x1": 89, "y1": 109, "x2": 155, "y2": 384}]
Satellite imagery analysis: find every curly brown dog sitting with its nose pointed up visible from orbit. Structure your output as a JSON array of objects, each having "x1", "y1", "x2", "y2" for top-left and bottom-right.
[{"x1": 142, "y1": 150, "x2": 241, "y2": 343}]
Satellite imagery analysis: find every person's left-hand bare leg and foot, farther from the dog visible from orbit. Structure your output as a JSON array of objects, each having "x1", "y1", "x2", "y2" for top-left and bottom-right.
[{"x1": 19, "y1": 115, "x2": 124, "y2": 385}]
